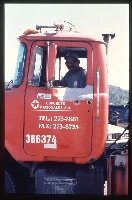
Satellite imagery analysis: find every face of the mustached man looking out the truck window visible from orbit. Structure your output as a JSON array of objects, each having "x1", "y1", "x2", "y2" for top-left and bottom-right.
[{"x1": 65, "y1": 57, "x2": 79, "y2": 71}]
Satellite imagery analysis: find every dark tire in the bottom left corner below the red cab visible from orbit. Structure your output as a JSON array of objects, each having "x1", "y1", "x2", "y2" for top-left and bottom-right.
[{"x1": 5, "y1": 168, "x2": 17, "y2": 194}]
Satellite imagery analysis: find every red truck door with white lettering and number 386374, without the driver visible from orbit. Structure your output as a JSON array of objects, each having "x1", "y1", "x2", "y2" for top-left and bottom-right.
[{"x1": 24, "y1": 41, "x2": 93, "y2": 164}]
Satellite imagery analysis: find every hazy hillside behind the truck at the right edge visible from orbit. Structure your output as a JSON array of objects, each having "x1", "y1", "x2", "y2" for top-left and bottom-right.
[{"x1": 109, "y1": 85, "x2": 129, "y2": 105}]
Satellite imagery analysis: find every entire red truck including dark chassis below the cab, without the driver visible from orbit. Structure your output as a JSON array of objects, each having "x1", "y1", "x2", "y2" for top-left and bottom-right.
[{"x1": 5, "y1": 23, "x2": 128, "y2": 195}]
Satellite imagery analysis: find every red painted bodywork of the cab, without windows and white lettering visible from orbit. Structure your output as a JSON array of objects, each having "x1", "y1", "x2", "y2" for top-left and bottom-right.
[{"x1": 5, "y1": 30, "x2": 108, "y2": 163}]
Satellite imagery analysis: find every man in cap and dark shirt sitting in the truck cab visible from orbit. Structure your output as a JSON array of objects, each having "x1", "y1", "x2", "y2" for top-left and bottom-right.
[{"x1": 53, "y1": 52, "x2": 86, "y2": 88}]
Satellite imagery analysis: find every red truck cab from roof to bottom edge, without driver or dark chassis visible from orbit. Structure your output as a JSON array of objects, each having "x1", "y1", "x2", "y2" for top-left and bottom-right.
[{"x1": 5, "y1": 23, "x2": 108, "y2": 164}]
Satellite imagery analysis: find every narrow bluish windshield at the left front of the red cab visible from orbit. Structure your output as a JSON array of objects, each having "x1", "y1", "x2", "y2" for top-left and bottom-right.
[{"x1": 12, "y1": 43, "x2": 27, "y2": 87}]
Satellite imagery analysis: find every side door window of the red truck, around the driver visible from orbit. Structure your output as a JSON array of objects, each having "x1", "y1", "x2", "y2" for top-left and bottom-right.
[{"x1": 28, "y1": 46, "x2": 87, "y2": 87}]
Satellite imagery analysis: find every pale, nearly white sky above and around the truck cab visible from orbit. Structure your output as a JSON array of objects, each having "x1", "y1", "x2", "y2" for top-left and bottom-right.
[{"x1": 5, "y1": 4, "x2": 129, "y2": 90}]
